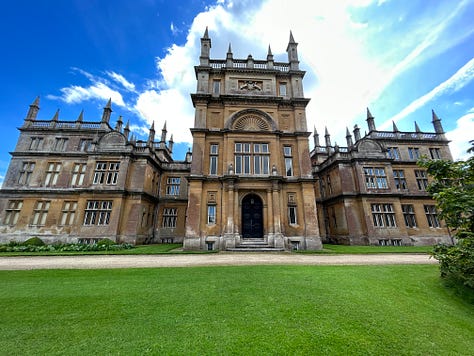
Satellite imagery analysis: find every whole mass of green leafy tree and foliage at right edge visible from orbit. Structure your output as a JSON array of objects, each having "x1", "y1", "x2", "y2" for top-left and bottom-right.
[{"x1": 418, "y1": 140, "x2": 474, "y2": 289}]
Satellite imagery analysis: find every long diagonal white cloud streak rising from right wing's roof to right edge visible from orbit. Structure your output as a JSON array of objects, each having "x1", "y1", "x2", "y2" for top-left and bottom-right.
[{"x1": 381, "y1": 58, "x2": 474, "y2": 129}]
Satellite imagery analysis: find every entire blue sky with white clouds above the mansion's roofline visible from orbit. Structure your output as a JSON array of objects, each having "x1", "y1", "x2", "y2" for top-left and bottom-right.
[{"x1": 0, "y1": 0, "x2": 474, "y2": 183}]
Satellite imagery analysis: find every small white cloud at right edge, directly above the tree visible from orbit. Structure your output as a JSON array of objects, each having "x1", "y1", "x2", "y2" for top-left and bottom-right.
[{"x1": 446, "y1": 108, "x2": 474, "y2": 160}]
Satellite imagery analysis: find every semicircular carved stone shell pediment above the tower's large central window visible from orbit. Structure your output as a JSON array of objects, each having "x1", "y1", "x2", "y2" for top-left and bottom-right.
[{"x1": 225, "y1": 109, "x2": 276, "y2": 131}]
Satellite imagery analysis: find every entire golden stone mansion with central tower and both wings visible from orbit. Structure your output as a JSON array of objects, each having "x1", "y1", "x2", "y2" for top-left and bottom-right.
[{"x1": 0, "y1": 29, "x2": 452, "y2": 251}]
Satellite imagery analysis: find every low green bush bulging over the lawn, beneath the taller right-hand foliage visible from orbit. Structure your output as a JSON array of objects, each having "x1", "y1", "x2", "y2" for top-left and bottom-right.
[{"x1": 433, "y1": 234, "x2": 474, "y2": 289}]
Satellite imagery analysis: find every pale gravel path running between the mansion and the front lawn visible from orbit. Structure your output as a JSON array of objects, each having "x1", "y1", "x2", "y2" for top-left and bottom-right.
[{"x1": 0, "y1": 252, "x2": 438, "y2": 270}]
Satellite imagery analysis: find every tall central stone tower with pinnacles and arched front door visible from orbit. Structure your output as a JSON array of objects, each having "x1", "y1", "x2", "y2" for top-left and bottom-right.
[{"x1": 184, "y1": 28, "x2": 321, "y2": 250}]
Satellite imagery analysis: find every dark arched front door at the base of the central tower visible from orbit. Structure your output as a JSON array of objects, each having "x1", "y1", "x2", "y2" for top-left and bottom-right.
[{"x1": 241, "y1": 194, "x2": 263, "y2": 239}]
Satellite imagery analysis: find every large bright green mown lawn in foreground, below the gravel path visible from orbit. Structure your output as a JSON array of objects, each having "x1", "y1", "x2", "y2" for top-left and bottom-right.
[{"x1": 0, "y1": 265, "x2": 474, "y2": 355}]
